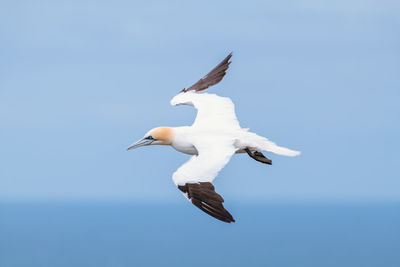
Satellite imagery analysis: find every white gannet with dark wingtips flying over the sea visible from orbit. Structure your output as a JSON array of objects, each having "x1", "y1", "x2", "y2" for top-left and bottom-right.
[{"x1": 127, "y1": 53, "x2": 300, "y2": 223}]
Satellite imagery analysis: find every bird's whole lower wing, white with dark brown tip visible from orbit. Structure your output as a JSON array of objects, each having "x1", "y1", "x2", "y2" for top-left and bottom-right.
[{"x1": 173, "y1": 137, "x2": 236, "y2": 223}]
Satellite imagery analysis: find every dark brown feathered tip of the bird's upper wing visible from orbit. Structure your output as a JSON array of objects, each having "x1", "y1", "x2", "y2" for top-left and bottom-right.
[{"x1": 182, "y1": 53, "x2": 232, "y2": 92}]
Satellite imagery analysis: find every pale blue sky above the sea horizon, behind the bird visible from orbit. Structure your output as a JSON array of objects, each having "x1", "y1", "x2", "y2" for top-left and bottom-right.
[{"x1": 0, "y1": 1, "x2": 400, "y2": 201}]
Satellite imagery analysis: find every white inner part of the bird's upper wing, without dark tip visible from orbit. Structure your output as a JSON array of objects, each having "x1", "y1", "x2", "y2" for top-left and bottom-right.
[{"x1": 171, "y1": 92, "x2": 240, "y2": 131}]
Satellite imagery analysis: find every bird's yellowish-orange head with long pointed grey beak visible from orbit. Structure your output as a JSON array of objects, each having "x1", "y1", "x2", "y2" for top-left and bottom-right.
[{"x1": 127, "y1": 127, "x2": 172, "y2": 150}]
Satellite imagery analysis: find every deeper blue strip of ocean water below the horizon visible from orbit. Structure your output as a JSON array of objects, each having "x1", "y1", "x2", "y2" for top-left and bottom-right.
[{"x1": 0, "y1": 202, "x2": 400, "y2": 267}]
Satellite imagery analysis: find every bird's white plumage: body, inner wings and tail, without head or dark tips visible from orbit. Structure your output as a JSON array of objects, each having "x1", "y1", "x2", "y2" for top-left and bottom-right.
[{"x1": 171, "y1": 91, "x2": 299, "y2": 185}]
